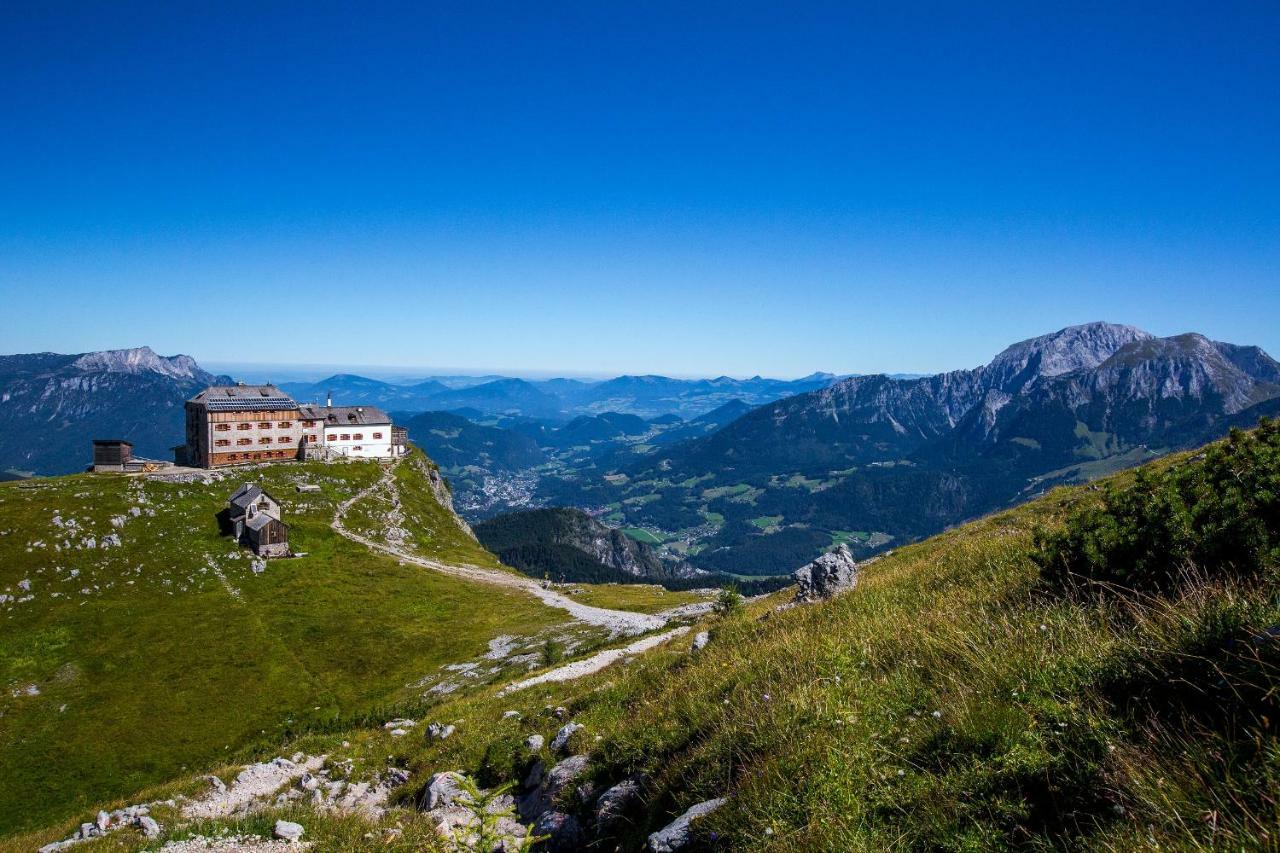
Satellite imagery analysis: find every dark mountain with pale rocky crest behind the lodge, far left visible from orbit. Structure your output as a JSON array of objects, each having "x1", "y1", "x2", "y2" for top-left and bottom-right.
[{"x1": 0, "y1": 347, "x2": 230, "y2": 474}]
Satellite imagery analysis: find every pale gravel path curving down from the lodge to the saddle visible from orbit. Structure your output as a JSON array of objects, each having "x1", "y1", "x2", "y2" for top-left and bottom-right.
[{"x1": 332, "y1": 467, "x2": 669, "y2": 635}]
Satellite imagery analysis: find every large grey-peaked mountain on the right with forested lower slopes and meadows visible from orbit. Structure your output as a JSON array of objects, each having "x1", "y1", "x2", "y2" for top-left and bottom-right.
[{"x1": 552, "y1": 323, "x2": 1280, "y2": 574}]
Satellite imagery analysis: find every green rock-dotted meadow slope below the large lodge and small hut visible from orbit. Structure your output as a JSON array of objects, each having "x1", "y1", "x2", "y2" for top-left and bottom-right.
[{"x1": 0, "y1": 455, "x2": 563, "y2": 834}]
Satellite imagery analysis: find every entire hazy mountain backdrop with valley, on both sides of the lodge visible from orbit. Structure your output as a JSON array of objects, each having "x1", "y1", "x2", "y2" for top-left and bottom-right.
[{"x1": 0, "y1": 323, "x2": 1280, "y2": 575}]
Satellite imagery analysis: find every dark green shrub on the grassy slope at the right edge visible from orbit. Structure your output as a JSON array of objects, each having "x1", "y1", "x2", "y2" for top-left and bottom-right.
[{"x1": 1034, "y1": 419, "x2": 1280, "y2": 592}]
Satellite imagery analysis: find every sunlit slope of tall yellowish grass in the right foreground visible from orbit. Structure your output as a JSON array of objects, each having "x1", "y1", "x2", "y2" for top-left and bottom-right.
[{"x1": 12, "y1": 435, "x2": 1280, "y2": 850}]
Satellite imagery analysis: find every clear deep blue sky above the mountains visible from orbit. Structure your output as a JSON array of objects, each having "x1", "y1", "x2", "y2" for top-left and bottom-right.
[{"x1": 0, "y1": 0, "x2": 1280, "y2": 375}]
